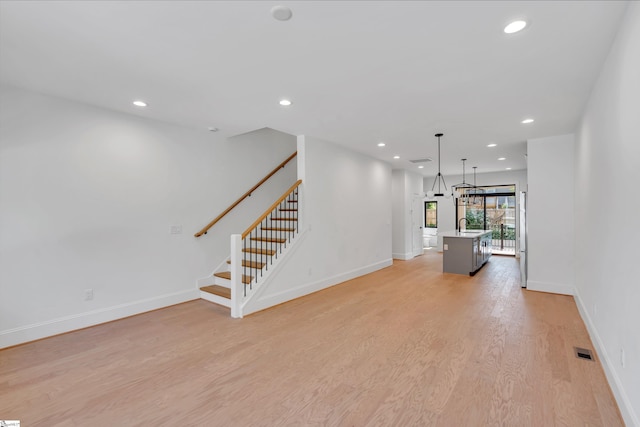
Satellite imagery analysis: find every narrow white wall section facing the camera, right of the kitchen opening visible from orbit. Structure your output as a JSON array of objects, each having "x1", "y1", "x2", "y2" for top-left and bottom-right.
[{"x1": 527, "y1": 134, "x2": 574, "y2": 295}]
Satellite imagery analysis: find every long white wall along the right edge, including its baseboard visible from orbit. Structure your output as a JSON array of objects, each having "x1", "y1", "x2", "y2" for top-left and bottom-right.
[{"x1": 574, "y1": 2, "x2": 640, "y2": 426}]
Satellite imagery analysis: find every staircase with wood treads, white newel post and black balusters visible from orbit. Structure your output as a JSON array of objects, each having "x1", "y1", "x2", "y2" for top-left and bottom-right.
[{"x1": 200, "y1": 181, "x2": 302, "y2": 317}]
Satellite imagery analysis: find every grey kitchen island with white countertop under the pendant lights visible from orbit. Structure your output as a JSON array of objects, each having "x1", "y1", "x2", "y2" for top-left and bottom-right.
[{"x1": 441, "y1": 230, "x2": 492, "y2": 276}]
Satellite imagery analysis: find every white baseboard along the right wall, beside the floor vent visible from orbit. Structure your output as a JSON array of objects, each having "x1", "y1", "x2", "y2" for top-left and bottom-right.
[{"x1": 574, "y1": 289, "x2": 640, "y2": 427}]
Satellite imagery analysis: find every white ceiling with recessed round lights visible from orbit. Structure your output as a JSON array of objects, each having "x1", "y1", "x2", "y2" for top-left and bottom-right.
[{"x1": 0, "y1": 1, "x2": 626, "y2": 176}]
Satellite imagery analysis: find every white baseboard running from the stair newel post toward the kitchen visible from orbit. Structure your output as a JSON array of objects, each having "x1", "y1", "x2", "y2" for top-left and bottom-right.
[{"x1": 242, "y1": 259, "x2": 393, "y2": 315}]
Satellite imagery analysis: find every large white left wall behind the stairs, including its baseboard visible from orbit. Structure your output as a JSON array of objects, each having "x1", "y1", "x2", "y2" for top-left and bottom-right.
[{"x1": 0, "y1": 86, "x2": 296, "y2": 347}]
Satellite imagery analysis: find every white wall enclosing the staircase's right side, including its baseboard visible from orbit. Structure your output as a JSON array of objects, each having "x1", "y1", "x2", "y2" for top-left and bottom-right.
[{"x1": 245, "y1": 136, "x2": 392, "y2": 313}]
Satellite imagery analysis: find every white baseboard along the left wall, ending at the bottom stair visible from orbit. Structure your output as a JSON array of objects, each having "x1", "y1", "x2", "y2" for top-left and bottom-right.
[{"x1": 0, "y1": 289, "x2": 200, "y2": 349}]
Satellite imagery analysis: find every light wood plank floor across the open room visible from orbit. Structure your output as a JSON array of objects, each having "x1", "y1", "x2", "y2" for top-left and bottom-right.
[{"x1": 0, "y1": 253, "x2": 623, "y2": 427}]
